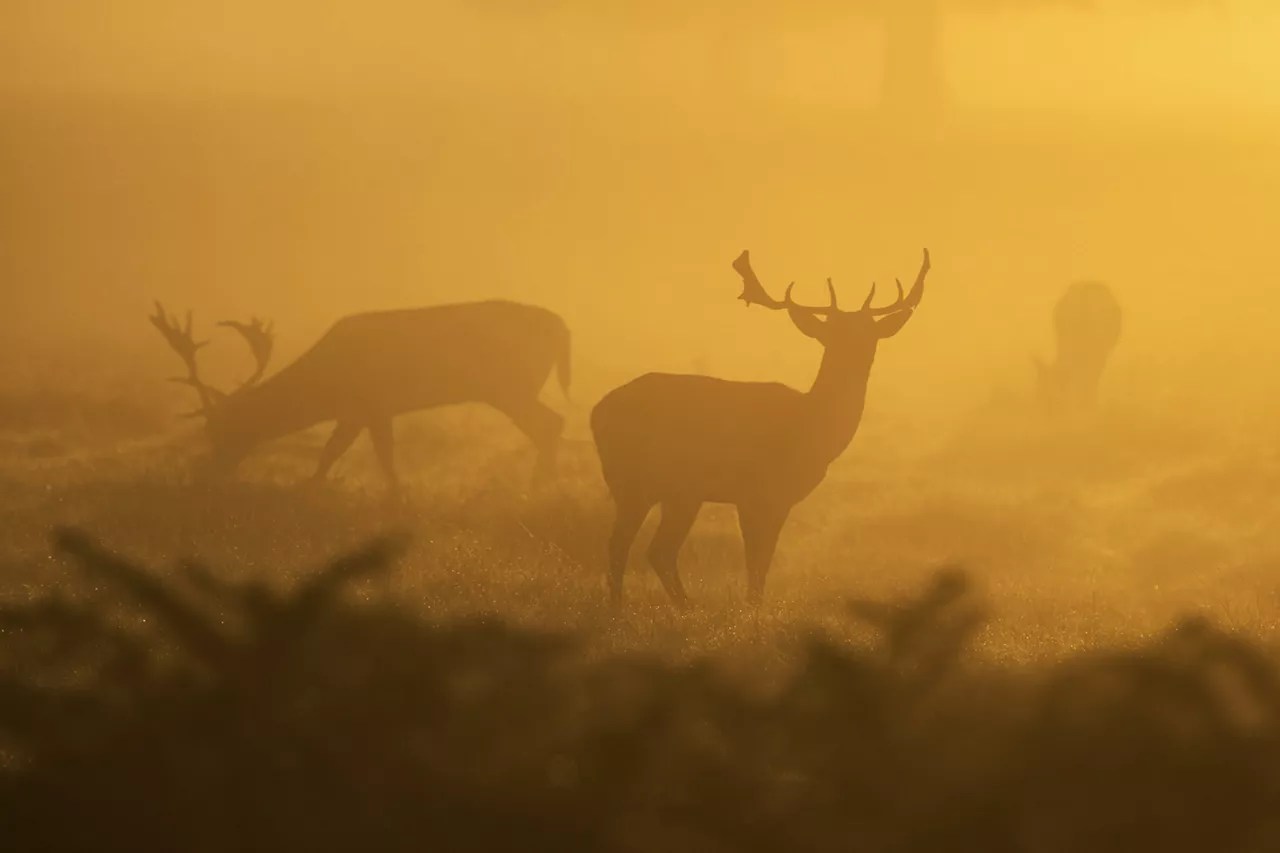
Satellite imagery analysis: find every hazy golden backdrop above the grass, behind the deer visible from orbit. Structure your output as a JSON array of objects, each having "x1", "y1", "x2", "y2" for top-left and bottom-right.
[{"x1": 0, "y1": 0, "x2": 1280, "y2": 437}]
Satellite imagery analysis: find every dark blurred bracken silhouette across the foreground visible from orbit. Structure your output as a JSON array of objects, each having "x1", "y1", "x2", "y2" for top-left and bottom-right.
[{"x1": 0, "y1": 532, "x2": 1280, "y2": 853}]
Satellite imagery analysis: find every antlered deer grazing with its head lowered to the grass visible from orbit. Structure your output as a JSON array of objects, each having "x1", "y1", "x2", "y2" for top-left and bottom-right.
[{"x1": 151, "y1": 301, "x2": 570, "y2": 492}]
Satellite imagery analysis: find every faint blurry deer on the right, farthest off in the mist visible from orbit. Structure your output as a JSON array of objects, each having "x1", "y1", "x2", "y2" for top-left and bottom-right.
[{"x1": 1036, "y1": 282, "x2": 1121, "y2": 412}]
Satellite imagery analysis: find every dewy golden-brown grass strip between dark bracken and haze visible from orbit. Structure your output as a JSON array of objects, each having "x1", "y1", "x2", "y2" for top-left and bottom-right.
[{"x1": 0, "y1": 384, "x2": 1280, "y2": 662}]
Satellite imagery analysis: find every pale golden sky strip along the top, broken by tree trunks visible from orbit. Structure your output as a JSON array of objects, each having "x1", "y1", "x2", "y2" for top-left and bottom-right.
[{"x1": 0, "y1": 0, "x2": 1280, "y2": 110}]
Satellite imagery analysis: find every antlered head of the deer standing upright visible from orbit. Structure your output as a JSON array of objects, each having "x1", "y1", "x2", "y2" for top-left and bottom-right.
[{"x1": 733, "y1": 248, "x2": 929, "y2": 356}]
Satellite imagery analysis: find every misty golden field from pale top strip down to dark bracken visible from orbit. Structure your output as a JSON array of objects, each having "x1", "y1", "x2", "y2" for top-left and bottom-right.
[{"x1": 0, "y1": 99, "x2": 1280, "y2": 660}]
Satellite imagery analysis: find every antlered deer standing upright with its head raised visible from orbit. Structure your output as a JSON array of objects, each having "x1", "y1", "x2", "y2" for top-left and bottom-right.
[{"x1": 591, "y1": 250, "x2": 929, "y2": 607}]
